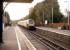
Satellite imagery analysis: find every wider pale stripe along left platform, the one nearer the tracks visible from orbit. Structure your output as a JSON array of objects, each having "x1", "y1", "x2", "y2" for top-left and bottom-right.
[{"x1": 17, "y1": 26, "x2": 37, "y2": 50}]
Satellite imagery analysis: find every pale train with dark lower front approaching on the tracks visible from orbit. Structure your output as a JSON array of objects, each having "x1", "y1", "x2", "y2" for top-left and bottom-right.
[{"x1": 17, "y1": 19, "x2": 36, "y2": 30}]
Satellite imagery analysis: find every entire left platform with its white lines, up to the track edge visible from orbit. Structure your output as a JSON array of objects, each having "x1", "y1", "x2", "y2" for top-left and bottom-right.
[{"x1": 0, "y1": 26, "x2": 50, "y2": 50}]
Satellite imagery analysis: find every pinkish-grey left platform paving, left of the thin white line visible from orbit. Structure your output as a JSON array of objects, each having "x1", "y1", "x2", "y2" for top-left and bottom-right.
[{"x1": 0, "y1": 27, "x2": 18, "y2": 50}]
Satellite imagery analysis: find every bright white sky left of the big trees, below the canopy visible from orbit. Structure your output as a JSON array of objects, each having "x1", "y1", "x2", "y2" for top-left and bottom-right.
[{"x1": 3, "y1": 0, "x2": 44, "y2": 20}]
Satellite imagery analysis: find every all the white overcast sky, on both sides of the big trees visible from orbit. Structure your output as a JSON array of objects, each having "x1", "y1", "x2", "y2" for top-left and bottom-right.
[{"x1": 4, "y1": 0, "x2": 70, "y2": 21}]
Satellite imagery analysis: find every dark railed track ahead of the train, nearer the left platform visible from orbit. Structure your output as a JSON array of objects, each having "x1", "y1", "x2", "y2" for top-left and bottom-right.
[{"x1": 28, "y1": 30, "x2": 66, "y2": 50}]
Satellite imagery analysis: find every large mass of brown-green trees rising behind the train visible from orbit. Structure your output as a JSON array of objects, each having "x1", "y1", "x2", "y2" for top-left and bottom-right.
[{"x1": 29, "y1": 0, "x2": 63, "y2": 24}]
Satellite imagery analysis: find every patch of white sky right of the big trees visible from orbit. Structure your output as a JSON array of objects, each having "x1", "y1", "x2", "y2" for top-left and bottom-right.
[{"x1": 58, "y1": 0, "x2": 70, "y2": 16}]
